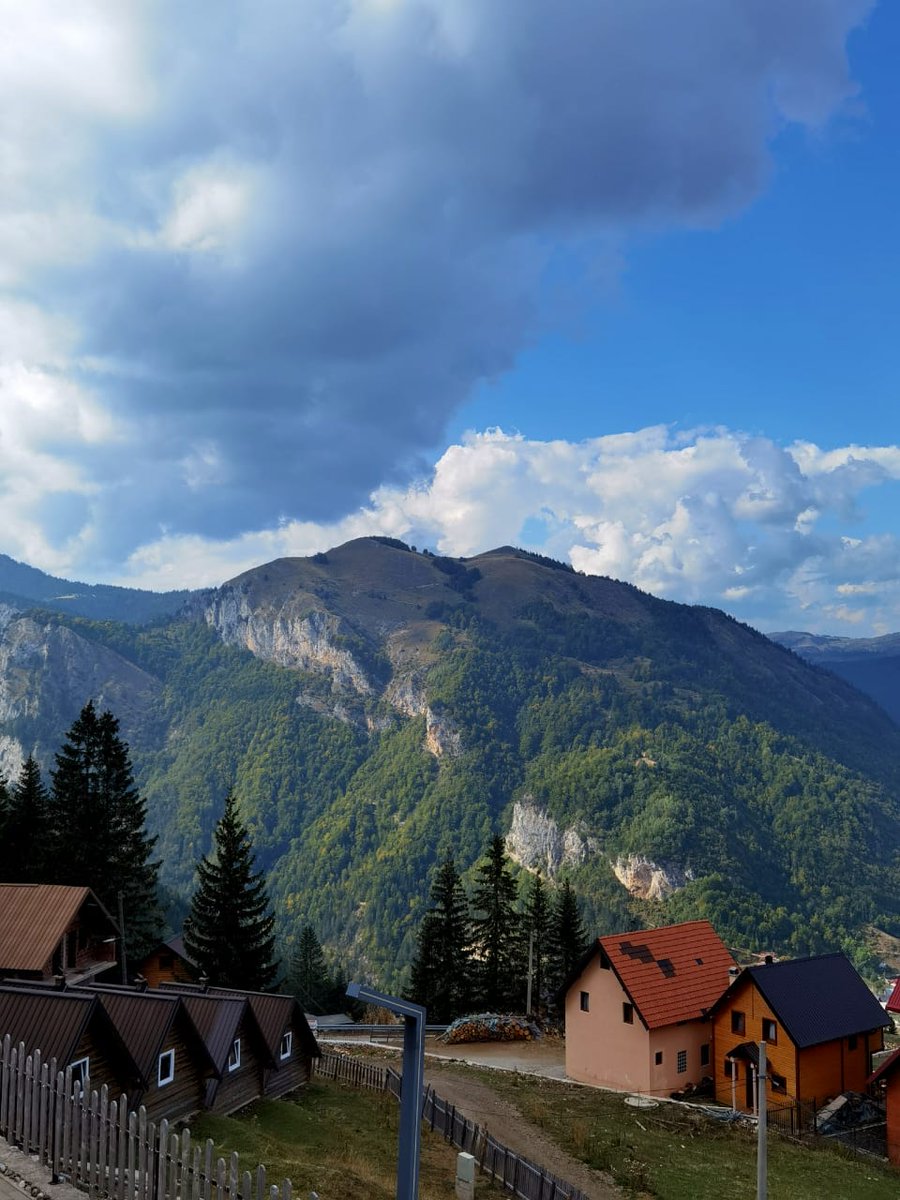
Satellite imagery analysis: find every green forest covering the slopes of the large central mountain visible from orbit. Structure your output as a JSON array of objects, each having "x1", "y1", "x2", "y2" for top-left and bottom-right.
[{"x1": 6, "y1": 544, "x2": 900, "y2": 988}]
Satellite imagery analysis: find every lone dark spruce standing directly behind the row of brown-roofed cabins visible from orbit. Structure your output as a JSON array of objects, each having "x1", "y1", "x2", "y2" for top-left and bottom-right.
[{"x1": 185, "y1": 794, "x2": 277, "y2": 991}]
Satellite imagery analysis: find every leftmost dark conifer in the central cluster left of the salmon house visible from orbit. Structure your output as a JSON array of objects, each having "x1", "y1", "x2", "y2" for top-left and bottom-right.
[{"x1": 408, "y1": 858, "x2": 472, "y2": 1024}]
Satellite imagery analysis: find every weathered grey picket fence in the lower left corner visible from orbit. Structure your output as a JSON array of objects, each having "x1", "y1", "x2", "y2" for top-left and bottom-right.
[{"x1": 0, "y1": 1034, "x2": 290, "y2": 1200}]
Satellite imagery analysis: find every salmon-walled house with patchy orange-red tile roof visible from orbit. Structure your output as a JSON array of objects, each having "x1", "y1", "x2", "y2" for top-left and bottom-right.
[{"x1": 565, "y1": 920, "x2": 734, "y2": 1096}]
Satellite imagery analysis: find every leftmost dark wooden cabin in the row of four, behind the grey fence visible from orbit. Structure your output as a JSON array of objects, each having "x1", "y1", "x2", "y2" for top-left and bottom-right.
[{"x1": 0, "y1": 985, "x2": 140, "y2": 1098}]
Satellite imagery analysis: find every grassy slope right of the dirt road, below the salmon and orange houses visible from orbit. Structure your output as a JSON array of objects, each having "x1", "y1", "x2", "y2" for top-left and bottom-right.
[{"x1": 479, "y1": 1072, "x2": 900, "y2": 1200}]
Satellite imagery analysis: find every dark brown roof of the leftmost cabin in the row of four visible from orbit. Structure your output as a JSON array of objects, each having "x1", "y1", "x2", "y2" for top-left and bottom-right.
[{"x1": 0, "y1": 988, "x2": 140, "y2": 1079}]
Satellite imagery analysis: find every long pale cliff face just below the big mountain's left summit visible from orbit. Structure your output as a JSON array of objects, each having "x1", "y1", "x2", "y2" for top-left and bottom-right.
[{"x1": 203, "y1": 588, "x2": 374, "y2": 696}]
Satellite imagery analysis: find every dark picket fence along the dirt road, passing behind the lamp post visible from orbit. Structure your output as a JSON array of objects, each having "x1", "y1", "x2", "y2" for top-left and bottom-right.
[{"x1": 314, "y1": 1054, "x2": 588, "y2": 1200}]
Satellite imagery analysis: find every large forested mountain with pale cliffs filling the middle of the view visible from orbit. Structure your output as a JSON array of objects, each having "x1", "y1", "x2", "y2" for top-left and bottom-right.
[{"x1": 0, "y1": 538, "x2": 900, "y2": 988}]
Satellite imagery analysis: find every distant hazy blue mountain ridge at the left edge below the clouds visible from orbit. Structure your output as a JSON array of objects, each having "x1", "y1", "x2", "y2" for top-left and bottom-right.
[{"x1": 0, "y1": 554, "x2": 191, "y2": 624}]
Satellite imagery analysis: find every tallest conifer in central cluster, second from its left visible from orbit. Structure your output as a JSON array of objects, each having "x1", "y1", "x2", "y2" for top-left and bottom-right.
[{"x1": 472, "y1": 834, "x2": 526, "y2": 1012}]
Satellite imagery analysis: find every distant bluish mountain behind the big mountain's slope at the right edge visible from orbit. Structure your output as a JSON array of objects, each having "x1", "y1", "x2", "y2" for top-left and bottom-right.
[{"x1": 769, "y1": 630, "x2": 900, "y2": 725}]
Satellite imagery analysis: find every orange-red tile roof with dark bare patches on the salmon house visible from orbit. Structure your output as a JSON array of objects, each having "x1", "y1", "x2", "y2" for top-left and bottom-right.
[{"x1": 598, "y1": 920, "x2": 734, "y2": 1030}]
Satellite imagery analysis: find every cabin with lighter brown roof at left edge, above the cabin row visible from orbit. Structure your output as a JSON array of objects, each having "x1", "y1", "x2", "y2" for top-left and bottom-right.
[{"x1": 0, "y1": 883, "x2": 119, "y2": 983}]
